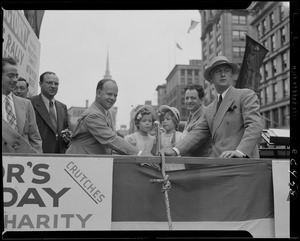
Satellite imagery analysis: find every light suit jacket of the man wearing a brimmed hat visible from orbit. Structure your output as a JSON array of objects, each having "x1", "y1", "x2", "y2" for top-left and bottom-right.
[{"x1": 176, "y1": 86, "x2": 263, "y2": 158}]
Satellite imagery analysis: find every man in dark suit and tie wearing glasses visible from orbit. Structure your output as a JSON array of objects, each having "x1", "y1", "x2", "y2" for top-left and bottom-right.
[{"x1": 29, "y1": 71, "x2": 70, "y2": 153}]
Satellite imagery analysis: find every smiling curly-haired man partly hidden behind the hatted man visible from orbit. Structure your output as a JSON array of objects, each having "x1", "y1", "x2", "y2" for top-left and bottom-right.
[{"x1": 183, "y1": 85, "x2": 212, "y2": 157}]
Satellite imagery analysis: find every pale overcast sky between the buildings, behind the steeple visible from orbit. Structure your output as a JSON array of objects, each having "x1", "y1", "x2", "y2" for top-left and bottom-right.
[{"x1": 39, "y1": 10, "x2": 202, "y2": 129}]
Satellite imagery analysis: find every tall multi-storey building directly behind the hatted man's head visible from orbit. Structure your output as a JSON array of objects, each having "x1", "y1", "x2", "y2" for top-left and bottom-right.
[{"x1": 199, "y1": 9, "x2": 253, "y2": 105}]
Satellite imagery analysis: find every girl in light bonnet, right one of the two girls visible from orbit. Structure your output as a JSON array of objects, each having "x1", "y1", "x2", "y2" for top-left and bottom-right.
[{"x1": 158, "y1": 105, "x2": 185, "y2": 171}]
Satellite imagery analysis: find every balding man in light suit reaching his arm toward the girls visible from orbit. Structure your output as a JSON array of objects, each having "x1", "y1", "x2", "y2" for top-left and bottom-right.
[{"x1": 66, "y1": 79, "x2": 142, "y2": 155}]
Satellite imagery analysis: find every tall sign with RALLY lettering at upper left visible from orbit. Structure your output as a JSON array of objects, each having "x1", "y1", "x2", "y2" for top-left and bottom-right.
[{"x1": 2, "y1": 10, "x2": 40, "y2": 96}]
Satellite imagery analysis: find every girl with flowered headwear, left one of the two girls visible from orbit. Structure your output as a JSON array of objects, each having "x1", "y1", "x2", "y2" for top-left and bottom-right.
[{"x1": 124, "y1": 106, "x2": 155, "y2": 156}]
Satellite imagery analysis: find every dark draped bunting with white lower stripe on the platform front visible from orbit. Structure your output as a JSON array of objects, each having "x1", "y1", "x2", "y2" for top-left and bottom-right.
[{"x1": 112, "y1": 157, "x2": 275, "y2": 238}]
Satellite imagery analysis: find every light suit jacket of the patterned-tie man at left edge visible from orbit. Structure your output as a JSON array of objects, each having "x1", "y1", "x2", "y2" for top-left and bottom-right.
[{"x1": 3, "y1": 94, "x2": 43, "y2": 153}]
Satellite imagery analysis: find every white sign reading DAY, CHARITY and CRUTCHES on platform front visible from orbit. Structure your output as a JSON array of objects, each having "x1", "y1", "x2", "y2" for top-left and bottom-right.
[{"x1": 3, "y1": 156, "x2": 113, "y2": 231}]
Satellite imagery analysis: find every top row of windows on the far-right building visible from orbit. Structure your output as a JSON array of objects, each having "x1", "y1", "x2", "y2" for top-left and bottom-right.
[{"x1": 256, "y1": 5, "x2": 285, "y2": 38}]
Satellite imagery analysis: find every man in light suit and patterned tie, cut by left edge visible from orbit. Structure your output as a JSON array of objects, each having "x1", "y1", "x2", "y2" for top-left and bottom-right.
[{"x1": 2, "y1": 58, "x2": 43, "y2": 153}]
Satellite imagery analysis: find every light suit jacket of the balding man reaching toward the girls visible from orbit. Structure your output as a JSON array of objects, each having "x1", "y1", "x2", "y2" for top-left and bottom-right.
[{"x1": 66, "y1": 101, "x2": 139, "y2": 155}]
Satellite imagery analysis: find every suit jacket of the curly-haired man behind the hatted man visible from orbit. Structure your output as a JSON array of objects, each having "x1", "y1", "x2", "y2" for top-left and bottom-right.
[{"x1": 183, "y1": 105, "x2": 212, "y2": 157}]
